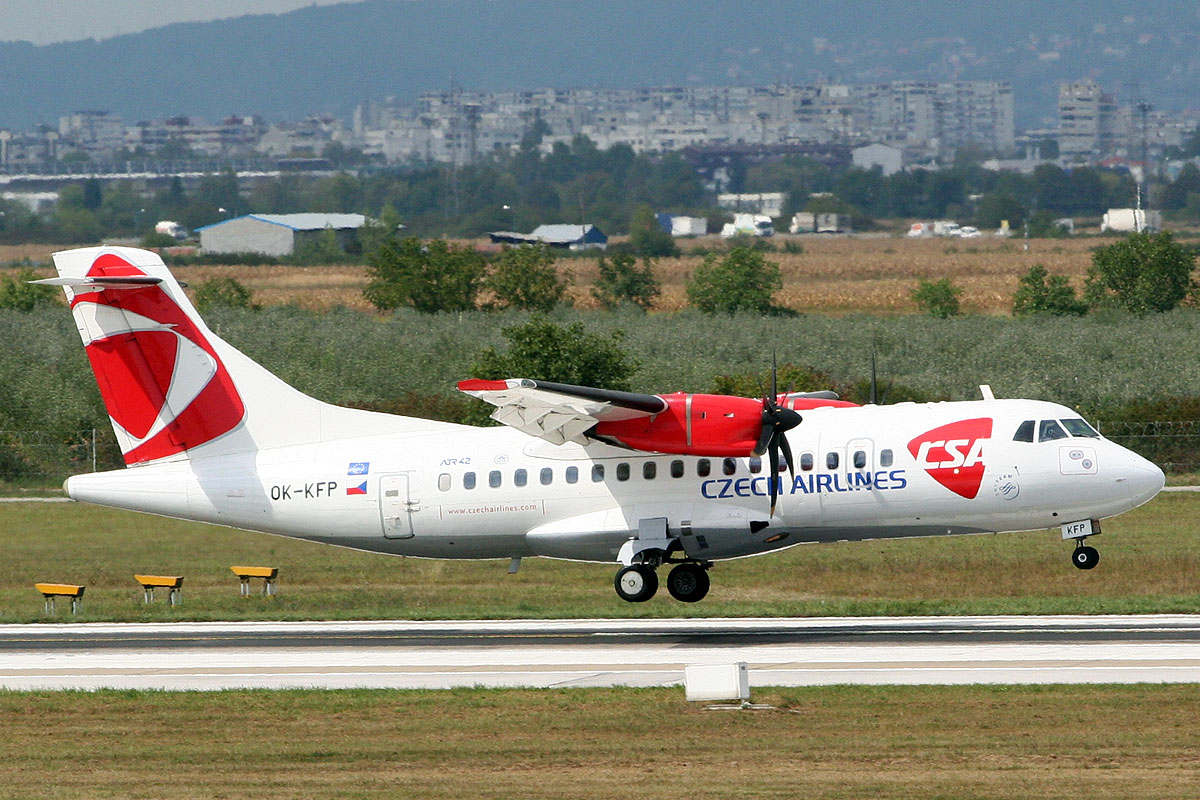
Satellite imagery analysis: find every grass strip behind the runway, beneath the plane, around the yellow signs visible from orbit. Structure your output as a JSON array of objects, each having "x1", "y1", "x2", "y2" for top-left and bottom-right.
[{"x1": 0, "y1": 493, "x2": 1200, "y2": 622}]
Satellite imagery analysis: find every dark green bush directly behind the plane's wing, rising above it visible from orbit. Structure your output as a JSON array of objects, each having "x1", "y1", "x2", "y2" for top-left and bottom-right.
[{"x1": 470, "y1": 314, "x2": 637, "y2": 390}]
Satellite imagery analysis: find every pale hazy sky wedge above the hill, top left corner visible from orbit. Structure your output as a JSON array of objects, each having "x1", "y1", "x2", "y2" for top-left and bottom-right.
[{"x1": 0, "y1": 0, "x2": 354, "y2": 44}]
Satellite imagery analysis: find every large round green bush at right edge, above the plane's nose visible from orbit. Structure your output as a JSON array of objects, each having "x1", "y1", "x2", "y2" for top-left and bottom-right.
[{"x1": 1084, "y1": 231, "x2": 1195, "y2": 314}]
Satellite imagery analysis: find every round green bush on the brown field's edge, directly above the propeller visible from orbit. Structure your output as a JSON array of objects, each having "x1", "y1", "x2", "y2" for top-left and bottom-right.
[{"x1": 688, "y1": 247, "x2": 784, "y2": 314}]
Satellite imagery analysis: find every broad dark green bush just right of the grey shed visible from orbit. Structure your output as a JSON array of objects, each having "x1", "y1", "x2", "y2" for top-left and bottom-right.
[{"x1": 362, "y1": 236, "x2": 487, "y2": 313}]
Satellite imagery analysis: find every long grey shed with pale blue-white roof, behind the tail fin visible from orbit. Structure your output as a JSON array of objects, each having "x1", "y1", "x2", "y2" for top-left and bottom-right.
[{"x1": 196, "y1": 213, "x2": 366, "y2": 257}]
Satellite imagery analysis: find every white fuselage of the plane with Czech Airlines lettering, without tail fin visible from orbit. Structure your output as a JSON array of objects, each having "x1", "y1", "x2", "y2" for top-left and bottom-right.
[{"x1": 67, "y1": 401, "x2": 1163, "y2": 563}]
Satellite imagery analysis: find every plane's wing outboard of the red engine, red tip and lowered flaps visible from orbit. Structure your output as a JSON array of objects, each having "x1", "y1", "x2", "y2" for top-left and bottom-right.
[{"x1": 458, "y1": 378, "x2": 667, "y2": 445}]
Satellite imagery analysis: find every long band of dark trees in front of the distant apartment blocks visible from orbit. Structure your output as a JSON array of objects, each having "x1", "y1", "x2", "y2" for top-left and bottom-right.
[{"x1": 7, "y1": 131, "x2": 1200, "y2": 243}]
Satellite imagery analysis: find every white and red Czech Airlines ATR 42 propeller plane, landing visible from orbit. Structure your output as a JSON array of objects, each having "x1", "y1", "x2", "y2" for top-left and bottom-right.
[{"x1": 40, "y1": 247, "x2": 1164, "y2": 602}]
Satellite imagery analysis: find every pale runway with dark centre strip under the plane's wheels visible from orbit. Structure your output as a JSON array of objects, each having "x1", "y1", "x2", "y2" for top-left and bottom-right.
[{"x1": 0, "y1": 615, "x2": 1200, "y2": 690}]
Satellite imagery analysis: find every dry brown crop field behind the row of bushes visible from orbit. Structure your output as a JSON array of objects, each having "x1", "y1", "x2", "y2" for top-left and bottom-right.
[{"x1": 0, "y1": 236, "x2": 1106, "y2": 314}]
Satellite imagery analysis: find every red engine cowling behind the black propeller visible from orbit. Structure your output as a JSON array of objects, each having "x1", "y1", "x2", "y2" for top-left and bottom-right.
[{"x1": 592, "y1": 392, "x2": 762, "y2": 458}]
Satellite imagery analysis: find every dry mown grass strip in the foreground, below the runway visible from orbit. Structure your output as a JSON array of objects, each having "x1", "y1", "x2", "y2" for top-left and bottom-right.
[{"x1": 0, "y1": 685, "x2": 1200, "y2": 800}]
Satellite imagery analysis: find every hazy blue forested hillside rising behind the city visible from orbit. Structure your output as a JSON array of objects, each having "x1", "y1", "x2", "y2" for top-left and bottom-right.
[{"x1": 0, "y1": 0, "x2": 1200, "y2": 128}]
